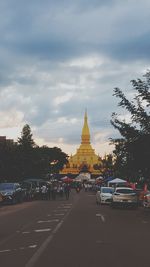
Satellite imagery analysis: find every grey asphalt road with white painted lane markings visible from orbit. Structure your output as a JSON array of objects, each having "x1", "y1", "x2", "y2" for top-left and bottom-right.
[{"x1": 0, "y1": 191, "x2": 150, "y2": 267}]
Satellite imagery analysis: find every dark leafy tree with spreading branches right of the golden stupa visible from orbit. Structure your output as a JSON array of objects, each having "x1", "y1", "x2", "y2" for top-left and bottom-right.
[{"x1": 111, "y1": 71, "x2": 150, "y2": 183}]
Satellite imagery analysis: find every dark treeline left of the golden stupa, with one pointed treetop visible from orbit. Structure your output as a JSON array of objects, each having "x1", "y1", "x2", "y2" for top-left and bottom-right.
[{"x1": 0, "y1": 124, "x2": 68, "y2": 181}]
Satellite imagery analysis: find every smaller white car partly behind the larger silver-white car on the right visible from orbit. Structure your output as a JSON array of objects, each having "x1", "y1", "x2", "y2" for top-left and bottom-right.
[{"x1": 96, "y1": 186, "x2": 114, "y2": 204}]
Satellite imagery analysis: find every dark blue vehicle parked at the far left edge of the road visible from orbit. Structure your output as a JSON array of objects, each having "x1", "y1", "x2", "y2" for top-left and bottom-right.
[{"x1": 0, "y1": 183, "x2": 24, "y2": 204}]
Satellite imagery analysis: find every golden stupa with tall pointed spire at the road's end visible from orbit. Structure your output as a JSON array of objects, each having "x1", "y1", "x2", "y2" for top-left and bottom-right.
[{"x1": 60, "y1": 112, "x2": 101, "y2": 175}]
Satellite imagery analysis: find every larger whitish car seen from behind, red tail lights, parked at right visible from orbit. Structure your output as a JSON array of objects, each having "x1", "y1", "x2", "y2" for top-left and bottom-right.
[{"x1": 111, "y1": 187, "x2": 138, "y2": 208}]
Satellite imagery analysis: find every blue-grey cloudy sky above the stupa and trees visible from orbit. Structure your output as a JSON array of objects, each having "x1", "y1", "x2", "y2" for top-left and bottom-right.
[{"x1": 0, "y1": 0, "x2": 150, "y2": 155}]
